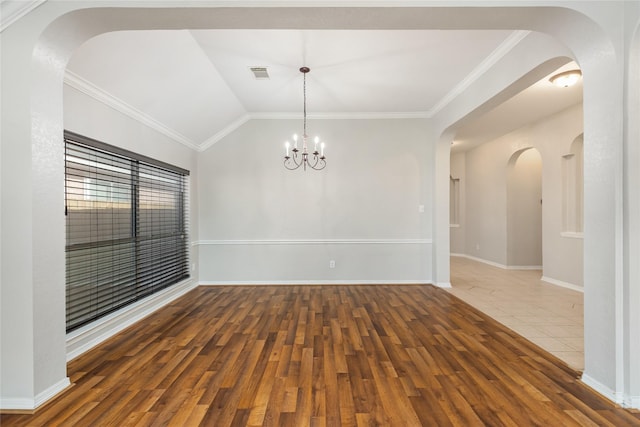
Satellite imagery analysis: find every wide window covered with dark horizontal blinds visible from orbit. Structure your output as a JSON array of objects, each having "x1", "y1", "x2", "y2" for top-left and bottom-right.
[{"x1": 65, "y1": 132, "x2": 189, "y2": 332}]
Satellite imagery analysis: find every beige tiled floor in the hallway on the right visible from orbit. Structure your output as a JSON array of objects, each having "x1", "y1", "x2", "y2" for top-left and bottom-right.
[{"x1": 448, "y1": 257, "x2": 584, "y2": 370}]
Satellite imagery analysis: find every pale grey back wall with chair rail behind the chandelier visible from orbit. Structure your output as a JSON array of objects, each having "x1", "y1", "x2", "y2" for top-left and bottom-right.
[{"x1": 198, "y1": 119, "x2": 433, "y2": 283}]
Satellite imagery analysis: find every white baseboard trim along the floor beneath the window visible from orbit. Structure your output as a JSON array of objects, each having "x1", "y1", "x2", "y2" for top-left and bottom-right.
[{"x1": 67, "y1": 280, "x2": 197, "y2": 361}]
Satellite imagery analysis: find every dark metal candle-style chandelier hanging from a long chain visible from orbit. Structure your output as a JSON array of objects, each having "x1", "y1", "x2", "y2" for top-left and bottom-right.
[{"x1": 284, "y1": 67, "x2": 327, "y2": 170}]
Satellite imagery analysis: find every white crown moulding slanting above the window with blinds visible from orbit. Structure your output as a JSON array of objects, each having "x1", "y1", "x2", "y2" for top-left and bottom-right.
[{"x1": 64, "y1": 70, "x2": 200, "y2": 150}]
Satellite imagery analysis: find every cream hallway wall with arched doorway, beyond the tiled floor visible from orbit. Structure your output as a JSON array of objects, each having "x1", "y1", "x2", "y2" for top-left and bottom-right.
[{"x1": 452, "y1": 105, "x2": 583, "y2": 287}]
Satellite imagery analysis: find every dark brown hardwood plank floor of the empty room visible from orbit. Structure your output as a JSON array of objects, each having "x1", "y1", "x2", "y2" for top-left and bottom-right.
[{"x1": 1, "y1": 285, "x2": 640, "y2": 427}]
